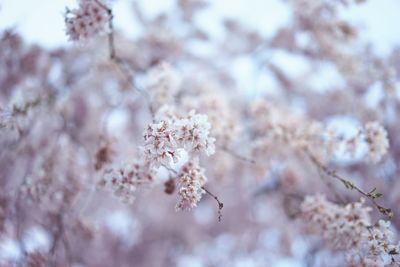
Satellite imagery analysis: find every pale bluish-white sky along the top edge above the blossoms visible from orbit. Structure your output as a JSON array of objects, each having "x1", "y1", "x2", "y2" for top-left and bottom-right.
[{"x1": 0, "y1": 0, "x2": 400, "y2": 53}]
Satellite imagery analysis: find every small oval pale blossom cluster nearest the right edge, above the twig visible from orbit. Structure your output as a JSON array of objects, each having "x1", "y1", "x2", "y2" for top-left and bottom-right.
[{"x1": 364, "y1": 122, "x2": 389, "y2": 162}]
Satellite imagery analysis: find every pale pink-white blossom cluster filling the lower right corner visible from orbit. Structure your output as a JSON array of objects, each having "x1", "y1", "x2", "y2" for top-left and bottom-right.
[{"x1": 301, "y1": 195, "x2": 399, "y2": 266}]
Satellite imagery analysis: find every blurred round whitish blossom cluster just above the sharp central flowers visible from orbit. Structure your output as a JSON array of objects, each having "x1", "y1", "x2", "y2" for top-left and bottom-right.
[{"x1": 144, "y1": 62, "x2": 181, "y2": 107}]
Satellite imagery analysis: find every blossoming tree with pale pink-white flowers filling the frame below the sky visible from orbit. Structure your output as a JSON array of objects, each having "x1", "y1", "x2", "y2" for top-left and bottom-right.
[{"x1": 0, "y1": 0, "x2": 400, "y2": 266}]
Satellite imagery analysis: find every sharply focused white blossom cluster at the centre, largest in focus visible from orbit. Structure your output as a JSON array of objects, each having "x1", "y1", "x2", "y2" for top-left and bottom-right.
[{"x1": 143, "y1": 111, "x2": 215, "y2": 170}]
